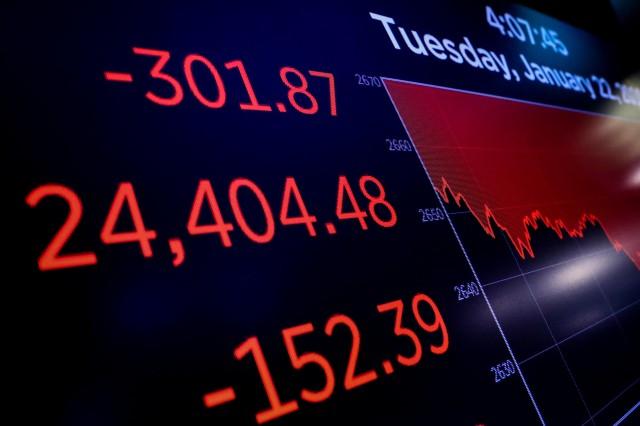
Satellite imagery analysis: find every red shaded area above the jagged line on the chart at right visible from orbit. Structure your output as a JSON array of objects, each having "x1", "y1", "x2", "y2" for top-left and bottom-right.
[{"x1": 385, "y1": 79, "x2": 640, "y2": 268}]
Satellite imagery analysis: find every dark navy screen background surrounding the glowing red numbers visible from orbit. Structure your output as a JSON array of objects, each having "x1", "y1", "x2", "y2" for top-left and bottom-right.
[{"x1": 2, "y1": 2, "x2": 639, "y2": 425}]
